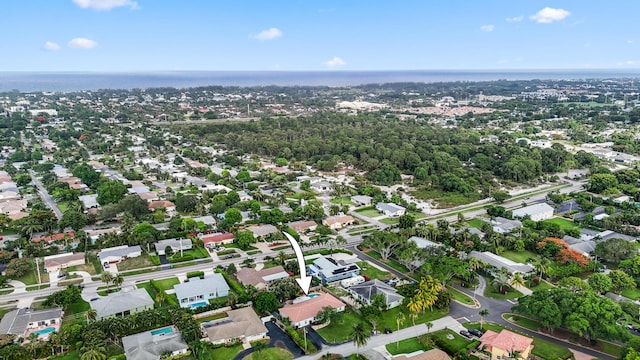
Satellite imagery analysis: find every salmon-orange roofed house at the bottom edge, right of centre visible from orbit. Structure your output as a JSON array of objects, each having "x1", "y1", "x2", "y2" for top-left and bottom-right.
[{"x1": 478, "y1": 329, "x2": 533, "y2": 360}]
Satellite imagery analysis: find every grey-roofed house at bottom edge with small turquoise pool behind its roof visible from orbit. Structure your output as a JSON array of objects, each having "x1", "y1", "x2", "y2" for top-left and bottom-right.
[{"x1": 122, "y1": 326, "x2": 189, "y2": 360}]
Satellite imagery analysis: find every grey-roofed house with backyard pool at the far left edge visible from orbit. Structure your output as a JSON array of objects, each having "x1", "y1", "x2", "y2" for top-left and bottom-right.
[{"x1": 0, "y1": 308, "x2": 63, "y2": 340}]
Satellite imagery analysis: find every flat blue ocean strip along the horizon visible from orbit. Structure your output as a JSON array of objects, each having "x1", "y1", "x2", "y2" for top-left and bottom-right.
[{"x1": 0, "y1": 70, "x2": 640, "y2": 92}]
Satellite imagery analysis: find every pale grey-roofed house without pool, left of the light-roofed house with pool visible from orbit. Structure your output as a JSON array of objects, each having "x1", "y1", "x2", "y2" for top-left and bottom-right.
[{"x1": 89, "y1": 287, "x2": 153, "y2": 319}]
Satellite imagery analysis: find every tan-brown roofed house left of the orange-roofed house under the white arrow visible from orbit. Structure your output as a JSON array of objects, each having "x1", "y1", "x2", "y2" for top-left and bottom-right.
[{"x1": 203, "y1": 307, "x2": 267, "y2": 344}]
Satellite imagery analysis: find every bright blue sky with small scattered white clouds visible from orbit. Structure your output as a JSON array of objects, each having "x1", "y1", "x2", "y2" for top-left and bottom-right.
[{"x1": 5, "y1": 0, "x2": 640, "y2": 72}]
